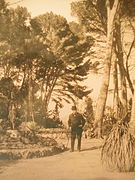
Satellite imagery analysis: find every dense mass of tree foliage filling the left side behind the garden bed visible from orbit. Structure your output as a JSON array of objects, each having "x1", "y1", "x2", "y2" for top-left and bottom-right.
[{"x1": 0, "y1": 0, "x2": 93, "y2": 129}]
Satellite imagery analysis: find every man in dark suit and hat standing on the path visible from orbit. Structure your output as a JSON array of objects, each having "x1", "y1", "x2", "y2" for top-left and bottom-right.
[{"x1": 68, "y1": 106, "x2": 85, "y2": 152}]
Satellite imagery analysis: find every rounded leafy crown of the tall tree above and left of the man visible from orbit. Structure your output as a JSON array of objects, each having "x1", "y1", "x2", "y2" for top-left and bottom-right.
[{"x1": 31, "y1": 12, "x2": 93, "y2": 101}]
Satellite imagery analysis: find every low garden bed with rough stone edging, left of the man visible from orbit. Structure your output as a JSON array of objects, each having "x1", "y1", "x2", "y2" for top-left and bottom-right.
[{"x1": 0, "y1": 129, "x2": 68, "y2": 160}]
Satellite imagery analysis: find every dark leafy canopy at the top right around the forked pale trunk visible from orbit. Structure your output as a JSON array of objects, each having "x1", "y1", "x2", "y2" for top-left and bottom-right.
[{"x1": 71, "y1": 0, "x2": 135, "y2": 34}]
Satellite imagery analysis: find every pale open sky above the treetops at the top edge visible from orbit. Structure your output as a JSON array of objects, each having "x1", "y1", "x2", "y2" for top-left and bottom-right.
[{"x1": 6, "y1": 0, "x2": 75, "y2": 21}]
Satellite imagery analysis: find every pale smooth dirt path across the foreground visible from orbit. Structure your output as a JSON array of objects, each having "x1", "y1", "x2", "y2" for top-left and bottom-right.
[{"x1": 0, "y1": 140, "x2": 135, "y2": 180}]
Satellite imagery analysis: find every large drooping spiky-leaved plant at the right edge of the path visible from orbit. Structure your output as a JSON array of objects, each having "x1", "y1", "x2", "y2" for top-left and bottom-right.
[{"x1": 101, "y1": 121, "x2": 135, "y2": 172}]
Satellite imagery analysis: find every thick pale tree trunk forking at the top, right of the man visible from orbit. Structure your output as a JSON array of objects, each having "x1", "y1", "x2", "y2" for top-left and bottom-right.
[{"x1": 95, "y1": 0, "x2": 119, "y2": 137}]
